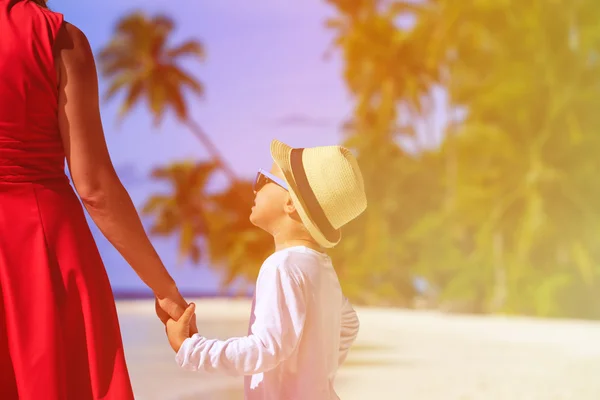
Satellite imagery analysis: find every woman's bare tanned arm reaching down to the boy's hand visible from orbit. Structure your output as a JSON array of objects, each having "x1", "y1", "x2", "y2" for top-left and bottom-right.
[{"x1": 55, "y1": 23, "x2": 187, "y2": 319}]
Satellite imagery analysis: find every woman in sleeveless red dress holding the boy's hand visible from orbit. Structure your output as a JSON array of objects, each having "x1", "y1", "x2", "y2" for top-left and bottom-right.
[{"x1": 0, "y1": 0, "x2": 195, "y2": 400}]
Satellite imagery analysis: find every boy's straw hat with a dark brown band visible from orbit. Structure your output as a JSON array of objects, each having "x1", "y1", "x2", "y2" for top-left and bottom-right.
[{"x1": 271, "y1": 140, "x2": 367, "y2": 248}]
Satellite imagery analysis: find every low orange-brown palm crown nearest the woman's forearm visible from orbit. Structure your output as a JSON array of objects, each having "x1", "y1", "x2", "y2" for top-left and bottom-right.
[{"x1": 142, "y1": 162, "x2": 215, "y2": 263}]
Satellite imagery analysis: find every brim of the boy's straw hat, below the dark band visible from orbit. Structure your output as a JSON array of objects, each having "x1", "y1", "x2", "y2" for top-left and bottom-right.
[{"x1": 271, "y1": 140, "x2": 342, "y2": 248}]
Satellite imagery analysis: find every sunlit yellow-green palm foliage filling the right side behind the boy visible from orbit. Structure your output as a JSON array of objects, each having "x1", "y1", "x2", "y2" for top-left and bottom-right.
[{"x1": 328, "y1": 0, "x2": 600, "y2": 318}]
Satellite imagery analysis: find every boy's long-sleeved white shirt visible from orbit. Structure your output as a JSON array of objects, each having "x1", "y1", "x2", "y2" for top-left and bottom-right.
[{"x1": 176, "y1": 246, "x2": 359, "y2": 400}]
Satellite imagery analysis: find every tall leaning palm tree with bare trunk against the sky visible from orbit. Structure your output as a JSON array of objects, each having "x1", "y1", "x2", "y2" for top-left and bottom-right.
[{"x1": 98, "y1": 12, "x2": 237, "y2": 182}]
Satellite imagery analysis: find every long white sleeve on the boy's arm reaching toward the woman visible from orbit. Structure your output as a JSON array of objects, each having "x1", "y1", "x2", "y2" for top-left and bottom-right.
[{"x1": 175, "y1": 260, "x2": 306, "y2": 375}]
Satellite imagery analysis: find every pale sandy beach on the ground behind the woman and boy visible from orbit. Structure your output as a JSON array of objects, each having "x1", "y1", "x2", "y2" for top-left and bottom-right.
[{"x1": 117, "y1": 299, "x2": 600, "y2": 400}]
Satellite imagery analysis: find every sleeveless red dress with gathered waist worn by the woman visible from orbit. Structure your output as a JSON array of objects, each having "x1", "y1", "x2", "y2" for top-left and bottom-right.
[{"x1": 0, "y1": 0, "x2": 133, "y2": 400}]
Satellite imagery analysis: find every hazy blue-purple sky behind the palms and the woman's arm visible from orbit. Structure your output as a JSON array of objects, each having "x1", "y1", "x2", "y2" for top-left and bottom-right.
[{"x1": 49, "y1": 0, "x2": 445, "y2": 294}]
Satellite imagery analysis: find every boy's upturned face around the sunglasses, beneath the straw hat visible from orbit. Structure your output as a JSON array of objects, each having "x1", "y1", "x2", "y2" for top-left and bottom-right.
[{"x1": 250, "y1": 163, "x2": 290, "y2": 234}]
